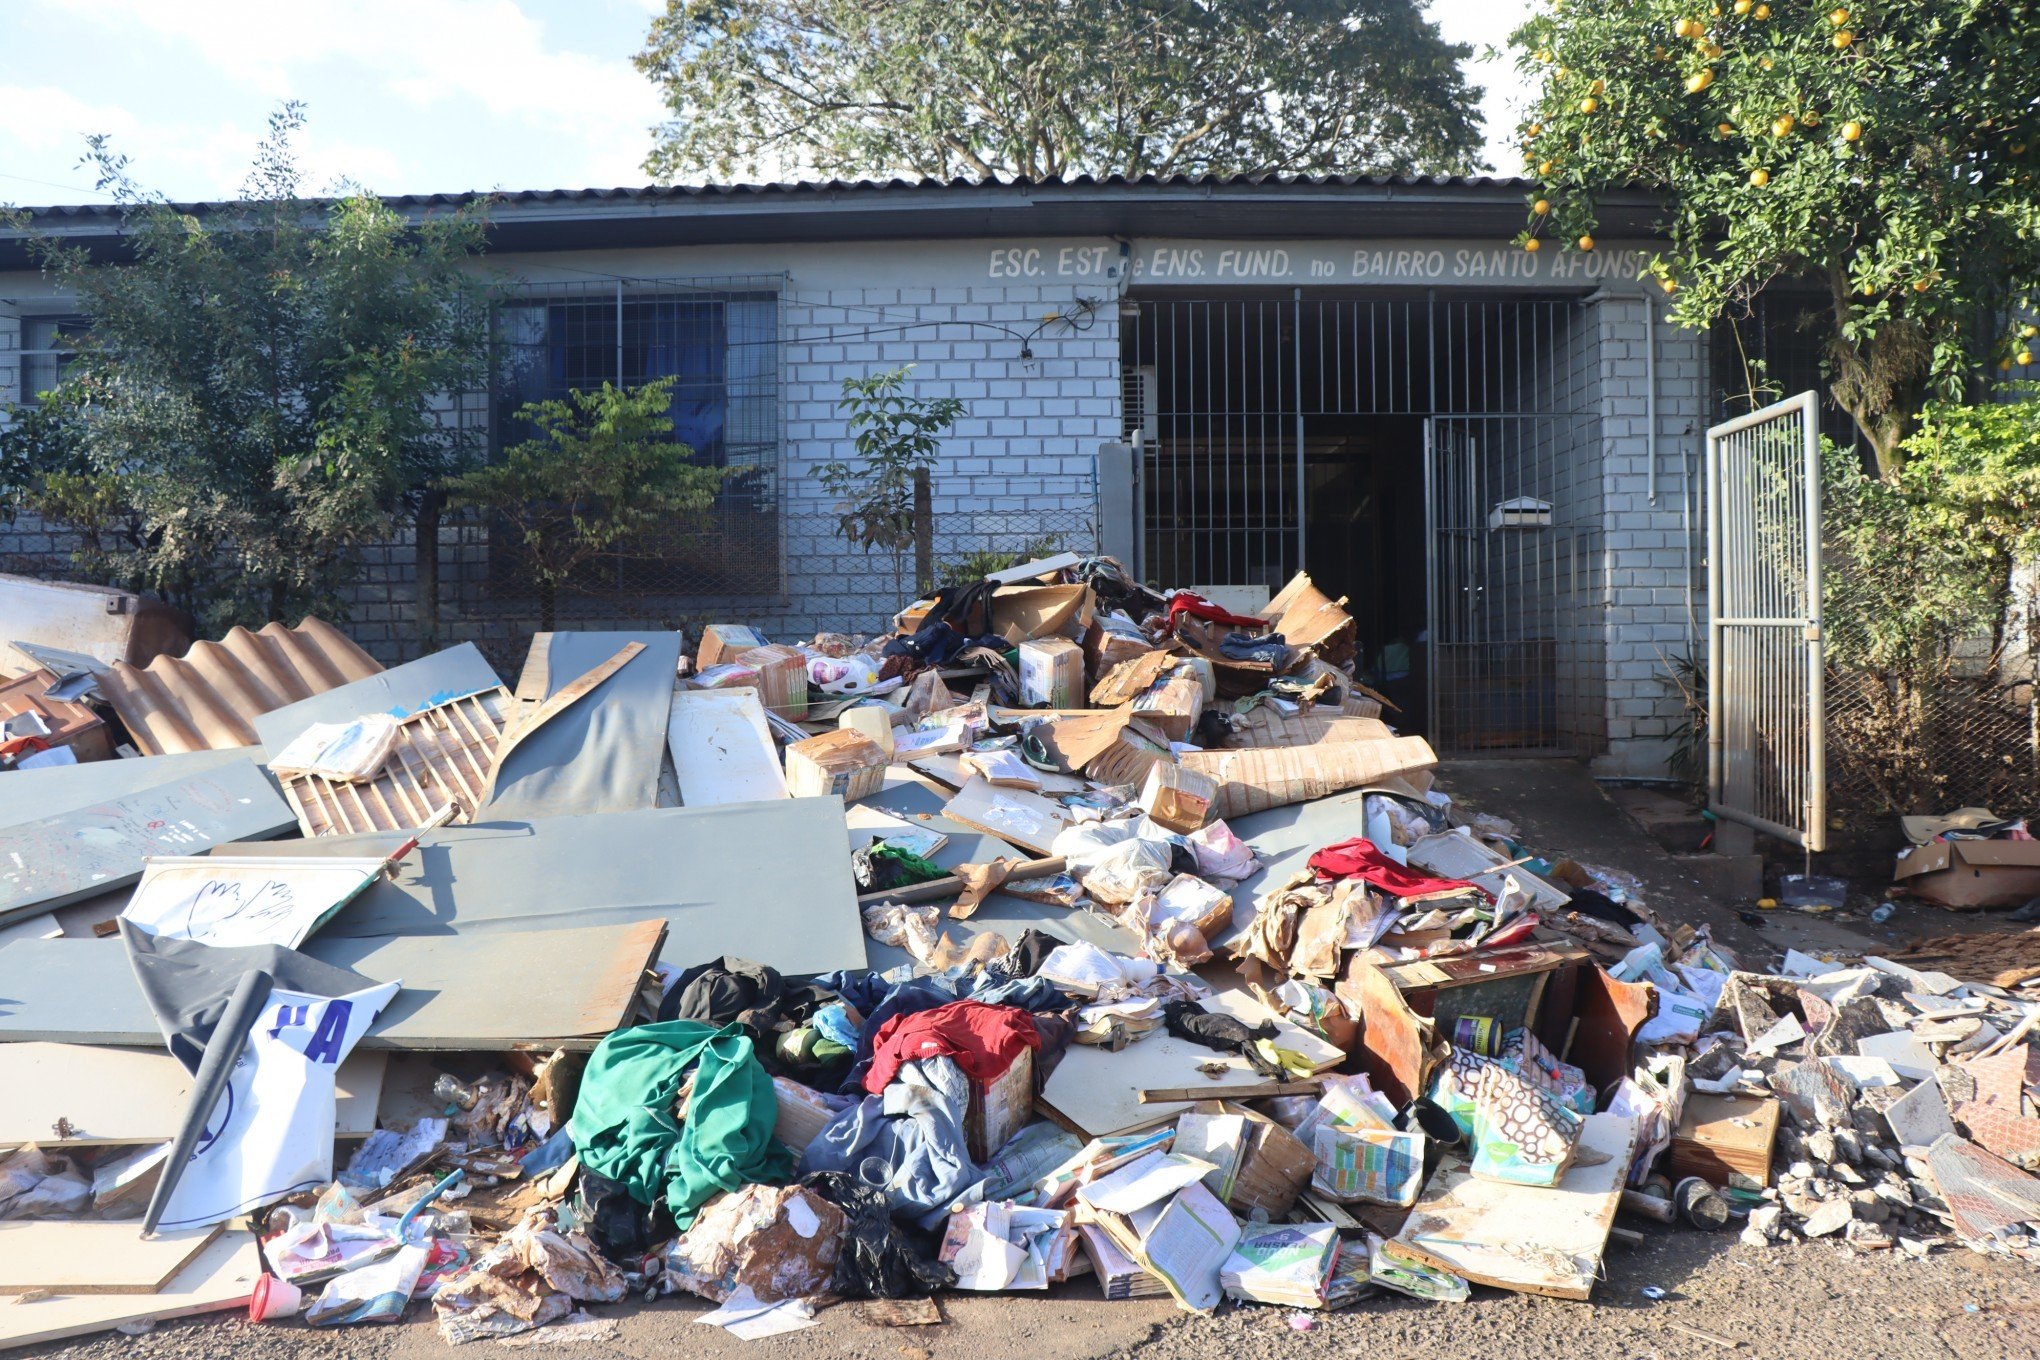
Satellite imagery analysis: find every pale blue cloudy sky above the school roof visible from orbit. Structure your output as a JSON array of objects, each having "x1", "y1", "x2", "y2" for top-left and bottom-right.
[{"x1": 0, "y1": 0, "x2": 1522, "y2": 204}]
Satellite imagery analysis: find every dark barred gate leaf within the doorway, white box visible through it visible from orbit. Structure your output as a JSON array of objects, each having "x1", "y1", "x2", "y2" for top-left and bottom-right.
[{"x1": 1424, "y1": 414, "x2": 1608, "y2": 754}]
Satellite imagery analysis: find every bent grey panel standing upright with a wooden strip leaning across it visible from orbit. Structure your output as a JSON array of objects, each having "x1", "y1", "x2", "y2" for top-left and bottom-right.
[{"x1": 475, "y1": 632, "x2": 679, "y2": 822}]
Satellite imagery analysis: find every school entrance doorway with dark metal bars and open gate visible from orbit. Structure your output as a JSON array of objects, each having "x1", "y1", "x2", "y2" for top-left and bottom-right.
[{"x1": 1122, "y1": 292, "x2": 1605, "y2": 754}]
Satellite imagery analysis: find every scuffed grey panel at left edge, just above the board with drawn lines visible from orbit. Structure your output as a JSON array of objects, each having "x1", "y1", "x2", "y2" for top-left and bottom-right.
[{"x1": 0, "y1": 752, "x2": 298, "y2": 924}]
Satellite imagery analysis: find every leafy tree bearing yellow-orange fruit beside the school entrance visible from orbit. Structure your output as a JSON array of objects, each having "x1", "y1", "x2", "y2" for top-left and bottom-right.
[{"x1": 1516, "y1": 0, "x2": 2040, "y2": 473}]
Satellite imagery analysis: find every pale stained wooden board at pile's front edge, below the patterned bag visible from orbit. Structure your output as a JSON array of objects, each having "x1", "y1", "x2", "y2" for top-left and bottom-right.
[{"x1": 1395, "y1": 1115, "x2": 1636, "y2": 1299}]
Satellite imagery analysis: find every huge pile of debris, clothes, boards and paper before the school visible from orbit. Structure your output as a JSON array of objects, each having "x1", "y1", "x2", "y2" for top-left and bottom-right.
[{"x1": 0, "y1": 555, "x2": 2040, "y2": 1346}]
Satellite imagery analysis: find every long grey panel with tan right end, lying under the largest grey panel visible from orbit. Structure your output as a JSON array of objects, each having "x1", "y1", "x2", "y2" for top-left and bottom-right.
[{"x1": 0, "y1": 924, "x2": 657, "y2": 1050}]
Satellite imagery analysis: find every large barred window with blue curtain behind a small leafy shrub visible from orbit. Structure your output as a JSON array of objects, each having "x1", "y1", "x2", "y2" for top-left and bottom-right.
[{"x1": 490, "y1": 275, "x2": 783, "y2": 595}]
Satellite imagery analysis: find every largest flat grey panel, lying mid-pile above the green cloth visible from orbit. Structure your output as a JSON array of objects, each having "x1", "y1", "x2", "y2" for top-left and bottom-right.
[{"x1": 215, "y1": 797, "x2": 865, "y2": 977}]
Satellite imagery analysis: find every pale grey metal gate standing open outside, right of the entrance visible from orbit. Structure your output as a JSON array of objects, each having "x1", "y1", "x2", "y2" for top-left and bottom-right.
[{"x1": 1707, "y1": 391, "x2": 1828, "y2": 850}]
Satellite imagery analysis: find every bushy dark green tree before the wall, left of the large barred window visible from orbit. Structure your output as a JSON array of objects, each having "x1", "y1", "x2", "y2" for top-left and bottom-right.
[{"x1": 0, "y1": 104, "x2": 490, "y2": 648}]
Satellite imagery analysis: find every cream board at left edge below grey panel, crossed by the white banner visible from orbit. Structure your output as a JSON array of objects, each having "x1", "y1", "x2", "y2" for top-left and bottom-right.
[{"x1": 0, "y1": 1042, "x2": 390, "y2": 1148}]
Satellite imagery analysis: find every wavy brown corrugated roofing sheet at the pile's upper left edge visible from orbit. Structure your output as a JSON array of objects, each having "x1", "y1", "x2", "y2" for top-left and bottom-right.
[{"x1": 100, "y1": 618, "x2": 381, "y2": 756}]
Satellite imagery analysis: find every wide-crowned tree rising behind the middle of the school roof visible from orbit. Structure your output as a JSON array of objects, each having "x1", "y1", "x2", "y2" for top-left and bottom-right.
[{"x1": 636, "y1": 0, "x2": 1481, "y2": 179}]
